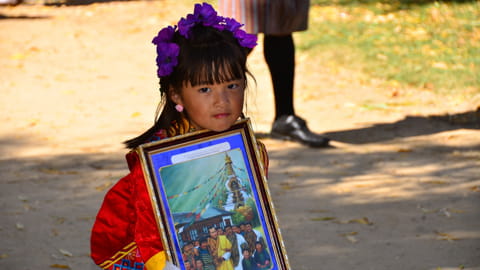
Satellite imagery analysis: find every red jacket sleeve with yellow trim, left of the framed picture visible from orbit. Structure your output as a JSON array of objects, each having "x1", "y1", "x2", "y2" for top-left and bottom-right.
[{"x1": 90, "y1": 151, "x2": 166, "y2": 269}]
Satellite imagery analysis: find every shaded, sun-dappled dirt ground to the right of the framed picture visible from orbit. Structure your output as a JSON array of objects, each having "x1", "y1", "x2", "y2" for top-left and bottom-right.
[{"x1": 269, "y1": 136, "x2": 480, "y2": 270}]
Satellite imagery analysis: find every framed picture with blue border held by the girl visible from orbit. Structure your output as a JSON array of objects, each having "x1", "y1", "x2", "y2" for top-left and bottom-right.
[{"x1": 138, "y1": 119, "x2": 290, "y2": 270}]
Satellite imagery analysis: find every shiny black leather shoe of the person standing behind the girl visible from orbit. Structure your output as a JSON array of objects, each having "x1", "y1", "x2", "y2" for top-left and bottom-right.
[{"x1": 271, "y1": 115, "x2": 330, "y2": 147}]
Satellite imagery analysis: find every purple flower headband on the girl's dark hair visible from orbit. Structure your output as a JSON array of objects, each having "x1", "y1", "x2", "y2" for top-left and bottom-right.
[{"x1": 152, "y1": 3, "x2": 257, "y2": 77}]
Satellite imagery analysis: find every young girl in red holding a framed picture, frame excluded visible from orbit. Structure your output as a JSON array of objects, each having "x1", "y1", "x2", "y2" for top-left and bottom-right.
[{"x1": 91, "y1": 3, "x2": 268, "y2": 270}]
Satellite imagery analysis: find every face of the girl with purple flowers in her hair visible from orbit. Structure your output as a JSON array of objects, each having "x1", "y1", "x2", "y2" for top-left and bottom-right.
[{"x1": 172, "y1": 79, "x2": 245, "y2": 131}]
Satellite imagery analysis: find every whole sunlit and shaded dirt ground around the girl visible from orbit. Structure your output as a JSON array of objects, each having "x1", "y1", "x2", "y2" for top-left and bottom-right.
[{"x1": 0, "y1": 0, "x2": 480, "y2": 270}]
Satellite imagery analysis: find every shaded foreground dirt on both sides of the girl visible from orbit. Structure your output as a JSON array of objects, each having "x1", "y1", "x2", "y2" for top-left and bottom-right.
[{"x1": 0, "y1": 127, "x2": 480, "y2": 270}]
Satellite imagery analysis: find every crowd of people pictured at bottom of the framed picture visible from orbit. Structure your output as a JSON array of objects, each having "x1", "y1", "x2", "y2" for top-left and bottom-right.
[{"x1": 182, "y1": 223, "x2": 272, "y2": 270}]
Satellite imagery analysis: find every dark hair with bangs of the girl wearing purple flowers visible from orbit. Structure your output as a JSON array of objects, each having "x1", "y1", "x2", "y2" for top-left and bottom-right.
[{"x1": 124, "y1": 25, "x2": 253, "y2": 148}]
